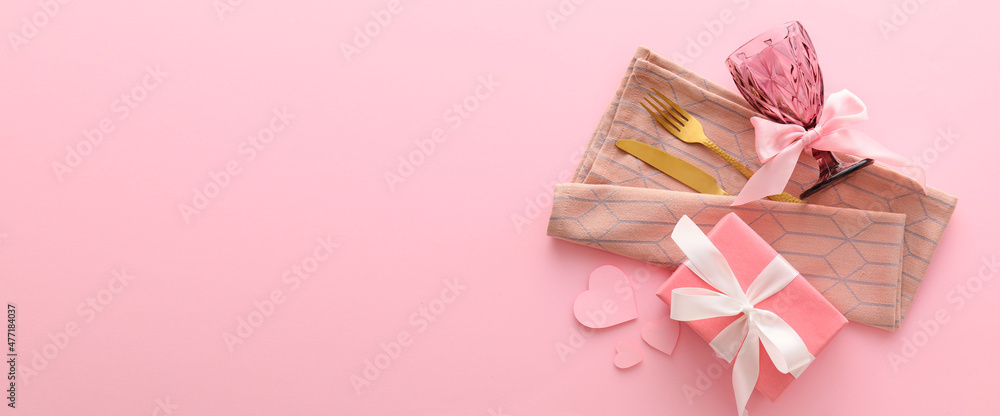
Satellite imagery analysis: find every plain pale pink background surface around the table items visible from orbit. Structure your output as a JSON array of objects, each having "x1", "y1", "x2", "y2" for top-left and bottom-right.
[{"x1": 0, "y1": 0, "x2": 1000, "y2": 415}]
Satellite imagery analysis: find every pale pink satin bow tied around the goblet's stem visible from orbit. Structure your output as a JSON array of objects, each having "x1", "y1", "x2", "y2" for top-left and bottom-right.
[{"x1": 733, "y1": 90, "x2": 927, "y2": 205}]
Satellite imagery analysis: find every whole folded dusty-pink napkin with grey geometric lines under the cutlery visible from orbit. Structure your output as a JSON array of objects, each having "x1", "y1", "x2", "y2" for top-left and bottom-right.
[{"x1": 549, "y1": 47, "x2": 957, "y2": 330}]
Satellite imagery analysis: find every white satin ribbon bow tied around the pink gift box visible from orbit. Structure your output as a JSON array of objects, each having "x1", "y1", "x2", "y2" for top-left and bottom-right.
[{"x1": 670, "y1": 215, "x2": 814, "y2": 415}]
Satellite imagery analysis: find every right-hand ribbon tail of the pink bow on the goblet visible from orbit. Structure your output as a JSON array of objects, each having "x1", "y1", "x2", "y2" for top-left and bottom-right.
[{"x1": 812, "y1": 129, "x2": 927, "y2": 192}]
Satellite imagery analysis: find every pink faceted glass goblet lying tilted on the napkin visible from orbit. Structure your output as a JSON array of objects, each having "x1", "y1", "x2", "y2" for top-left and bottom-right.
[{"x1": 726, "y1": 22, "x2": 872, "y2": 199}]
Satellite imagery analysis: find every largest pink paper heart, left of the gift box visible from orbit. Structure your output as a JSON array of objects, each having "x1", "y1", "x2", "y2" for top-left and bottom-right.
[{"x1": 573, "y1": 266, "x2": 638, "y2": 328}]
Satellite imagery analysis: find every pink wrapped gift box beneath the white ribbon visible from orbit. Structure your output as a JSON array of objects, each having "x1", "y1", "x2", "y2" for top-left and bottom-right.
[{"x1": 656, "y1": 214, "x2": 847, "y2": 401}]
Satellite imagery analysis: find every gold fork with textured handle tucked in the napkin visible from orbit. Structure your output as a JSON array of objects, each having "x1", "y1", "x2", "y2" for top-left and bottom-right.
[{"x1": 639, "y1": 88, "x2": 802, "y2": 203}]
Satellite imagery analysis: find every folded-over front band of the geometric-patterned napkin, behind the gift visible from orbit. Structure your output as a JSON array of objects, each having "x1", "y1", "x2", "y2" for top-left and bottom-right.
[{"x1": 549, "y1": 183, "x2": 905, "y2": 329}]
